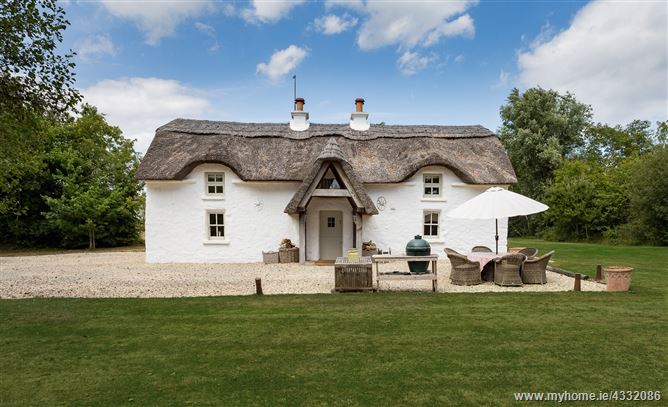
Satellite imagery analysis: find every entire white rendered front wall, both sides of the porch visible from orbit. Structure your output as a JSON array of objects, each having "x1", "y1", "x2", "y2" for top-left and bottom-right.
[{"x1": 146, "y1": 164, "x2": 508, "y2": 263}]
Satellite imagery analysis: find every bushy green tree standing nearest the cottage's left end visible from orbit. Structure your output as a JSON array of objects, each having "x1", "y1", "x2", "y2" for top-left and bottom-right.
[{"x1": 43, "y1": 106, "x2": 144, "y2": 248}]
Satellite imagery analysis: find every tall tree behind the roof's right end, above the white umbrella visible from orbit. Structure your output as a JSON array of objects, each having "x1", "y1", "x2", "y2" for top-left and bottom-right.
[{"x1": 498, "y1": 88, "x2": 592, "y2": 199}]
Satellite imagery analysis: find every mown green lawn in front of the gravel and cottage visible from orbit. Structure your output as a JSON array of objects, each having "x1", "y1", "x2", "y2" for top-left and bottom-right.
[{"x1": 0, "y1": 240, "x2": 668, "y2": 406}]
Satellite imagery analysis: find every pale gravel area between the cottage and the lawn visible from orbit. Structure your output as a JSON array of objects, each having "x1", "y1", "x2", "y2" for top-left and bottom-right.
[{"x1": 0, "y1": 252, "x2": 605, "y2": 298}]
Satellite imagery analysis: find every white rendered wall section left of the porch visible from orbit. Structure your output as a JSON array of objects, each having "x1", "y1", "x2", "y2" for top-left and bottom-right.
[{"x1": 146, "y1": 164, "x2": 302, "y2": 263}]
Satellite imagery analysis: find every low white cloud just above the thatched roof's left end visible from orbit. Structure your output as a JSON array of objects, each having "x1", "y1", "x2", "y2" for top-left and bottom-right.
[{"x1": 82, "y1": 78, "x2": 210, "y2": 152}]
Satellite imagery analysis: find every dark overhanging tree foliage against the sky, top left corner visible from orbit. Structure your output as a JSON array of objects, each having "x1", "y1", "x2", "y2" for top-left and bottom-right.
[{"x1": 0, "y1": 0, "x2": 81, "y2": 117}]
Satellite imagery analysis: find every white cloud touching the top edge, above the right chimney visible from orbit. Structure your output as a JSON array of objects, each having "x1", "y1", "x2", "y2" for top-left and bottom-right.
[{"x1": 357, "y1": 0, "x2": 477, "y2": 50}]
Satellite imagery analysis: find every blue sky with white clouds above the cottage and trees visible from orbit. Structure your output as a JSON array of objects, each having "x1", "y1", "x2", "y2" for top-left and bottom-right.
[{"x1": 60, "y1": 0, "x2": 668, "y2": 153}]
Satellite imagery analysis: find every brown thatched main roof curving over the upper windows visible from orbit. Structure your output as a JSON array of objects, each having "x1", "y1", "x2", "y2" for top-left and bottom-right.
[{"x1": 137, "y1": 119, "x2": 517, "y2": 184}]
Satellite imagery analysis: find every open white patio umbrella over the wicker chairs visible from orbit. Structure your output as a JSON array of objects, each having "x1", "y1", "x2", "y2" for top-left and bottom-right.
[{"x1": 445, "y1": 187, "x2": 549, "y2": 254}]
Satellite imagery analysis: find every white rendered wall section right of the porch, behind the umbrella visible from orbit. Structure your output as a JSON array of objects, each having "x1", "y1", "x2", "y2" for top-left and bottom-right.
[{"x1": 362, "y1": 166, "x2": 508, "y2": 256}]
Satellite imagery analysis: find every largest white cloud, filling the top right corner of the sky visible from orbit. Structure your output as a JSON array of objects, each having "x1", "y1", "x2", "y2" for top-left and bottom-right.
[{"x1": 517, "y1": 1, "x2": 668, "y2": 124}]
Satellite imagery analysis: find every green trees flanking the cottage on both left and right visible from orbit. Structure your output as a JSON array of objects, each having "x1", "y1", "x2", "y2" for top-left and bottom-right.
[{"x1": 0, "y1": 0, "x2": 668, "y2": 248}]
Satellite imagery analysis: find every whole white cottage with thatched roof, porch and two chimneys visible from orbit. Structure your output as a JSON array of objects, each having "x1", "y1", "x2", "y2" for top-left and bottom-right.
[{"x1": 137, "y1": 99, "x2": 516, "y2": 262}]
